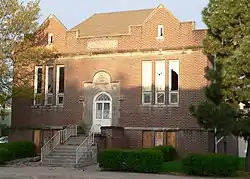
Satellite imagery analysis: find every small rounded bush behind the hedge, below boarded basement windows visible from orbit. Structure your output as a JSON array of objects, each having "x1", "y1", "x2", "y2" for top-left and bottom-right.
[{"x1": 154, "y1": 145, "x2": 177, "y2": 162}]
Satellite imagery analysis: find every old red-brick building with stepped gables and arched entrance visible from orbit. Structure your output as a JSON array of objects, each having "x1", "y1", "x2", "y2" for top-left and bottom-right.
[{"x1": 12, "y1": 5, "x2": 237, "y2": 153}]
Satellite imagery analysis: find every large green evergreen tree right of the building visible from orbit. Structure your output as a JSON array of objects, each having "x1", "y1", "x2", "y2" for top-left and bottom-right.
[{"x1": 190, "y1": 0, "x2": 250, "y2": 171}]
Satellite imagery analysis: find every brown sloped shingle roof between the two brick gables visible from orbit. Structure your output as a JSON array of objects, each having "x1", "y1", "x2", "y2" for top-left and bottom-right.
[{"x1": 71, "y1": 9, "x2": 154, "y2": 36}]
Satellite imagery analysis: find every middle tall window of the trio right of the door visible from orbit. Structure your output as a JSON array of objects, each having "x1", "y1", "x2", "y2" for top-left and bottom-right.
[{"x1": 155, "y1": 60, "x2": 166, "y2": 104}]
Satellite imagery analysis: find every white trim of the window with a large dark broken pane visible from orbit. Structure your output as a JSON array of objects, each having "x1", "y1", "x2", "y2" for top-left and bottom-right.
[{"x1": 168, "y1": 60, "x2": 180, "y2": 105}]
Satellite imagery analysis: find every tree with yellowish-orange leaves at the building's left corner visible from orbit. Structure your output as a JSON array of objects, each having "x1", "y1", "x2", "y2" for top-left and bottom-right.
[{"x1": 0, "y1": 0, "x2": 57, "y2": 106}]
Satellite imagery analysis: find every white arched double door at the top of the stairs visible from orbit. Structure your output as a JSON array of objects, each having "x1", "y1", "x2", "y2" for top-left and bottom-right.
[{"x1": 93, "y1": 92, "x2": 112, "y2": 133}]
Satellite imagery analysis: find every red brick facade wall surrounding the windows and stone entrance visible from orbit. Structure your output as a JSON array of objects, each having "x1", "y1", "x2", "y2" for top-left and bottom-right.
[{"x1": 12, "y1": 6, "x2": 211, "y2": 151}]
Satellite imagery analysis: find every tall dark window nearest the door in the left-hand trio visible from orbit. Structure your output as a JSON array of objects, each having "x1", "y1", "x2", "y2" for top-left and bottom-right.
[{"x1": 56, "y1": 65, "x2": 64, "y2": 105}]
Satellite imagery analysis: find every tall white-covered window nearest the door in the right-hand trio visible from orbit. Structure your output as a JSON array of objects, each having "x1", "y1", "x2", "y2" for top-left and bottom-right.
[{"x1": 142, "y1": 61, "x2": 152, "y2": 104}]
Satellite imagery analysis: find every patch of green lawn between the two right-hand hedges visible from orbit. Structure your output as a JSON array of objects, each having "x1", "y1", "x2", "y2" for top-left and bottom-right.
[{"x1": 162, "y1": 160, "x2": 183, "y2": 174}]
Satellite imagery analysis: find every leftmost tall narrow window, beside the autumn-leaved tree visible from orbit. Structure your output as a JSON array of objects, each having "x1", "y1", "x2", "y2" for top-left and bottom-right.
[{"x1": 34, "y1": 66, "x2": 43, "y2": 105}]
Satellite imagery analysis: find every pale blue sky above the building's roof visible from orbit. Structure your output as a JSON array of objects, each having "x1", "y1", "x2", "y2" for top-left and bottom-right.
[{"x1": 39, "y1": 0, "x2": 209, "y2": 29}]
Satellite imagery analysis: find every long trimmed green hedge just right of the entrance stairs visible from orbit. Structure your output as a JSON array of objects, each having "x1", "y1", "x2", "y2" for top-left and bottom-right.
[{"x1": 97, "y1": 149, "x2": 163, "y2": 173}]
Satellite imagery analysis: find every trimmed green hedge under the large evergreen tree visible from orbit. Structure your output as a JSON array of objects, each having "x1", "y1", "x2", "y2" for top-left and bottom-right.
[{"x1": 182, "y1": 154, "x2": 239, "y2": 177}]
